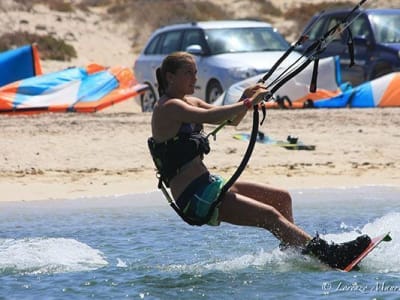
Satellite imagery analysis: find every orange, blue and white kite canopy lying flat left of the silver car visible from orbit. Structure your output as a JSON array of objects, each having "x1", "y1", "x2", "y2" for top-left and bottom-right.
[{"x1": 0, "y1": 44, "x2": 147, "y2": 113}]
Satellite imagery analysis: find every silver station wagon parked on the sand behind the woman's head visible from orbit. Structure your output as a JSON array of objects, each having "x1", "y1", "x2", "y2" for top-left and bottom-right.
[{"x1": 134, "y1": 20, "x2": 300, "y2": 111}]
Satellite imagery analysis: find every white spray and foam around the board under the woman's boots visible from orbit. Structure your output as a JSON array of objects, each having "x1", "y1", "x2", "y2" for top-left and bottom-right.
[{"x1": 164, "y1": 213, "x2": 400, "y2": 273}]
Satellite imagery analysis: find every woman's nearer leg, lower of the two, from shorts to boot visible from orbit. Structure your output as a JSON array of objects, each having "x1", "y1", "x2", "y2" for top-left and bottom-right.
[{"x1": 219, "y1": 191, "x2": 311, "y2": 247}]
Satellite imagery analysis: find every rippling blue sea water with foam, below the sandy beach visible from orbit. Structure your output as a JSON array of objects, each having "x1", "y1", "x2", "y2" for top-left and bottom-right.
[{"x1": 0, "y1": 187, "x2": 400, "y2": 299}]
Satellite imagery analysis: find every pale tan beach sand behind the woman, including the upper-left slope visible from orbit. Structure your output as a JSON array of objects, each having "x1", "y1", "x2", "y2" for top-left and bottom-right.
[{"x1": 0, "y1": 1, "x2": 400, "y2": 201}]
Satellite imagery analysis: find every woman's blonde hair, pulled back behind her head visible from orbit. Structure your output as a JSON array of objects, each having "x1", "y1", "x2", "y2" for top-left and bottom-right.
[{"x1": 156, "y1": 51, "x2": 194, "y2": 97}]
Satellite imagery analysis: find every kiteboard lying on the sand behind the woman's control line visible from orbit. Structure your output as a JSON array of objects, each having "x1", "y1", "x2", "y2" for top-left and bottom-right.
[{"x1": 233, "y1": 131, "x2": 315, "y2": 150}]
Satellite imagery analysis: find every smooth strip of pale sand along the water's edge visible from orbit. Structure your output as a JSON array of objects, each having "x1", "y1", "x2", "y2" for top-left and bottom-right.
[{"x1": 0, "y1": 176, "x2": 400, "y2": 203}]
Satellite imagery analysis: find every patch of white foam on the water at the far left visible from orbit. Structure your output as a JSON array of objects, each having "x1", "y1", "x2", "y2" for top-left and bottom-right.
[{"x1": 0, "y1": 238, "x2": 108, "y2": 274}]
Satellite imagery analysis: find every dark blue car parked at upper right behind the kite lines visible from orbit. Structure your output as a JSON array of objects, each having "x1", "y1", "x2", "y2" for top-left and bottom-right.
[{"x1": 299, "y1": 9, "x2": 400, "y2": 85}]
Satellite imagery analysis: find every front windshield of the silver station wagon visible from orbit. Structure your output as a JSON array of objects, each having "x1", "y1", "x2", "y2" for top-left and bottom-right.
[{"x1": 205, "y1": 27, "x2": 289, "y2": 54}]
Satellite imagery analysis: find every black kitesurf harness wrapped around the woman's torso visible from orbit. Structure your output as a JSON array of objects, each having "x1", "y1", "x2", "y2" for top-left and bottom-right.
[{"x1": 147, "y1": 123, "x2": 210, "y2": 187}]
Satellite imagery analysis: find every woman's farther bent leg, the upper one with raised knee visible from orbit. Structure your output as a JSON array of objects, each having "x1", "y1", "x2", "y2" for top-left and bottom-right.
[{"x1": 230, "y1": 181, "x2": 294, "y2": 223}]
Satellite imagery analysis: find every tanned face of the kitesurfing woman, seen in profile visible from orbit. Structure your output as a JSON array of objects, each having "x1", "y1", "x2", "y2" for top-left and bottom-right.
[{"x1": 169, "y1": 60, "x2": 197, "y2": 95}]
